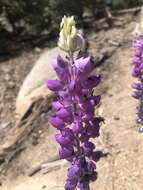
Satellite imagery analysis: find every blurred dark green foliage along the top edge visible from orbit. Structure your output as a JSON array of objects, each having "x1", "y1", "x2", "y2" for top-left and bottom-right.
[{"x1": 0, "y1": 0, "x2": 143, "y2": 35}]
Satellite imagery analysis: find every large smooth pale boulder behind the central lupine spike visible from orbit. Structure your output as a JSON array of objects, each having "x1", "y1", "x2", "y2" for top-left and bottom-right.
[{"x1": 16, "y1": 47, "x2": 65, "y2": 119}]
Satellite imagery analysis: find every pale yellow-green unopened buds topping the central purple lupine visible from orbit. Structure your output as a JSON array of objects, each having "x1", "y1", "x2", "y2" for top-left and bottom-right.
[{"x1": 58, "y1": 16, "x2": 83, "y2": 52}]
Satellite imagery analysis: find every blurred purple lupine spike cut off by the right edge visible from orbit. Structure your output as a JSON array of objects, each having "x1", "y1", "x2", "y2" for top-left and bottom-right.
[{"x1": 132, "y1": 21, "x2": 143, "y2": 132}]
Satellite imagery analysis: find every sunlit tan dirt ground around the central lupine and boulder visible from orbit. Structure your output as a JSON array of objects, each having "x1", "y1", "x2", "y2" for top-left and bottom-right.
[{"x1": 0, "y1": 14, "x2": 143, "y2": 190}]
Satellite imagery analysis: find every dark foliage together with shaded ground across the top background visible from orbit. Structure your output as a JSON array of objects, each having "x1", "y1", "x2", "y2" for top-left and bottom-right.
[{"x1": 0, "y1": 0, "x2": 143, "y2": 54}]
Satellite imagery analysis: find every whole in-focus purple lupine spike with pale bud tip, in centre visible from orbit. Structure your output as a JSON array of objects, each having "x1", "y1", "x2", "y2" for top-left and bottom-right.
[{"x1": 47, "y1": 16, "x2": 103, "y2": 190}]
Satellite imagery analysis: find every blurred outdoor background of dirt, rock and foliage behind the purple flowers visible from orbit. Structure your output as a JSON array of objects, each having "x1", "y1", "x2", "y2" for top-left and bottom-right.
[{"x1": 0, "y1": 0, "x2": 143, "y2": 190}]
